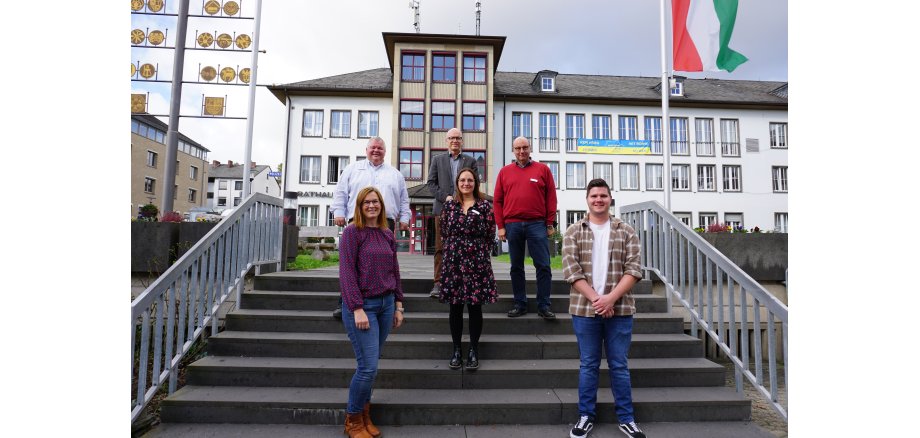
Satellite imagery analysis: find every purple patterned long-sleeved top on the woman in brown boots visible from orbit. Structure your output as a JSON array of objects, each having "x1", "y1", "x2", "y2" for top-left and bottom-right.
[{"x1": 339, "y1": 224, "x2": 403, "y2": 312}]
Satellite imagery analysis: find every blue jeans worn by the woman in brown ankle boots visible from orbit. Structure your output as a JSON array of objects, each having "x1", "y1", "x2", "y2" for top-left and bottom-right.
[{"x1": 342, "y1": 294, "x2": 396, "y2": 414}]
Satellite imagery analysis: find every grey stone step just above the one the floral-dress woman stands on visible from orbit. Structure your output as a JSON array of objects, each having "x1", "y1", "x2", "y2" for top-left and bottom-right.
[{"x1": 208, "y1": 332, "x2": 703, "y2": 360}]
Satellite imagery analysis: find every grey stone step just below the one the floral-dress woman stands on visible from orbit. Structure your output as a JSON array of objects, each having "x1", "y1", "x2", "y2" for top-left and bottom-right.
[{"x1": 160, "y1": 385, "x2": 751, "y2": 425}]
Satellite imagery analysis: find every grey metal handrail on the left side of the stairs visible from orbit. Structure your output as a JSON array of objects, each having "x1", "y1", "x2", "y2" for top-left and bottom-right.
[{"x1": 131, "y1": 193, "x2": 282, "y2": 422}]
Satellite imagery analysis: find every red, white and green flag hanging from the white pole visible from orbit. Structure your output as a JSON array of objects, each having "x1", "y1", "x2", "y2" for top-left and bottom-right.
[{"x1": 671, "y1": 0, "x2": 747, "y2": 72}]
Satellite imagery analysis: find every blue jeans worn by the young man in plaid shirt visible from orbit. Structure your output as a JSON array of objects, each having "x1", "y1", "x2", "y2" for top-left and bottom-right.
[{"x1": 572, "y1": 315, "x2": 635, "y2": 423}]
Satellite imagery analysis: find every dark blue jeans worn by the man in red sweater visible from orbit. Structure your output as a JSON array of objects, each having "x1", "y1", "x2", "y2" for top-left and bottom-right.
[{"x1": 505, "y1": 220, "x2": 553, "y2": 309}]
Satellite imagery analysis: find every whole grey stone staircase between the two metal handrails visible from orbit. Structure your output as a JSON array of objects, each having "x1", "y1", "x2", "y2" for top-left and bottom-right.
[{"x1": 151, "y1": 271, "x2": 770, "y2": 437}]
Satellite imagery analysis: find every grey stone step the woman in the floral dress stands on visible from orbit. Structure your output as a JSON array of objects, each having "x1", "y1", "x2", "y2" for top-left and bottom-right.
[{"x1": 186, "y1": 358, "x2": 725, "y2": 389}]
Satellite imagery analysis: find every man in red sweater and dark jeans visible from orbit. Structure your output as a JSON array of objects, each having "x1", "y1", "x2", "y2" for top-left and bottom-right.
[{"x1": 494, "y1": 137, "x2": 556, "y2": 320}]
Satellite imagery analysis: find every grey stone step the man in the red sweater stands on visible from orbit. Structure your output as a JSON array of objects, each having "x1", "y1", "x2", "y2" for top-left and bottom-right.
[{"x1": 225, "y1": 304, "x2": 684, "y2": 334}]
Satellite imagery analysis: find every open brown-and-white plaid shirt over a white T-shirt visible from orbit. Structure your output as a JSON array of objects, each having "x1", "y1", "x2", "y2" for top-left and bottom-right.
[{"x1": 562, "y1": 216, "x2": 642, "y2": 317}]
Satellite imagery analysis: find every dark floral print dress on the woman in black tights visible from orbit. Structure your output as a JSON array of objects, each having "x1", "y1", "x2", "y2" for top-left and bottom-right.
[{"x1": 439, "y1": 200, "x2": 498, "y2": 305}]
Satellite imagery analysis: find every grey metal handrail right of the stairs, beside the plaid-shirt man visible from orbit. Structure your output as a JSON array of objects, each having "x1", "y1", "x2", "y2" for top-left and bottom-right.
[{"x1": 620, "y1": 201, "x2": 789, "y2": 421}]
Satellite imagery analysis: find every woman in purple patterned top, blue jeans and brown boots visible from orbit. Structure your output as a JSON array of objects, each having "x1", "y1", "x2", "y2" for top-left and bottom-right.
[{"x1": 339, "y1": 187, "x2": 403, "y2": 438}]
